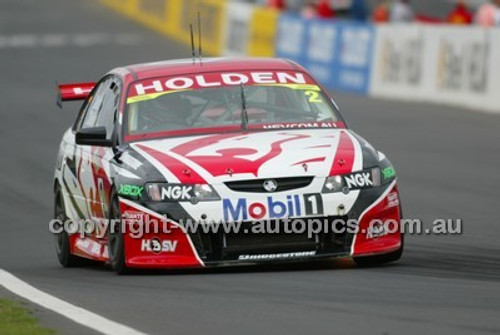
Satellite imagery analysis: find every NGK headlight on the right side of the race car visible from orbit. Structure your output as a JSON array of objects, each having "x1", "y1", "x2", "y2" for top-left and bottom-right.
[{"x1": 322, "y1": 167, "x2": 380, "y2": 194}]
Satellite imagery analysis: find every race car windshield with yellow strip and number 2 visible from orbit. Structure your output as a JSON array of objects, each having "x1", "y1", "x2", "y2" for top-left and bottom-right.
[{"x1": 125, "y1": 74, "x2": 339, "y2": 140}]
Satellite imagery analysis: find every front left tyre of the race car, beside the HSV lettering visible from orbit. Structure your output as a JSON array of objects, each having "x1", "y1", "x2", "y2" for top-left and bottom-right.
[{"x1": 108, "y1": 193, "x2": 129, "y2": 275}]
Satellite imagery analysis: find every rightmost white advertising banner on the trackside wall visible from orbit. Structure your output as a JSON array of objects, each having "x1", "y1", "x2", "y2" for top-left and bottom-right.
[{"x1": 425, "y1": 27, "x2": 500, "y2": 110}]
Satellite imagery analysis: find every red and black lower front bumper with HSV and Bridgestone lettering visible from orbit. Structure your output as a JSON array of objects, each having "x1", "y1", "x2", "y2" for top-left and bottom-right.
[{"x1": 120, "y1": 181, "x2": 401, "y2": 268}]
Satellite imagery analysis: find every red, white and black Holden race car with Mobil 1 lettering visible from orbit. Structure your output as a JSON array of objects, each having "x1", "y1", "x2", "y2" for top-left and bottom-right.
[{"x1": 54, "y1": 58, "x2": 403, "y2": 273}]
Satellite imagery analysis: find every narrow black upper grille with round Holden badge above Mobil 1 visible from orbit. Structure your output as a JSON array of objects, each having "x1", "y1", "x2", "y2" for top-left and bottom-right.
[{"x1": 225, "y1": 177, "x2": 313, "y2": 193}]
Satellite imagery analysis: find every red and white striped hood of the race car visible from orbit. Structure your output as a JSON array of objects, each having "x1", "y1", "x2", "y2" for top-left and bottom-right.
[{"x1": 131, "y1": 129, "x2": 363, "y2": 183}]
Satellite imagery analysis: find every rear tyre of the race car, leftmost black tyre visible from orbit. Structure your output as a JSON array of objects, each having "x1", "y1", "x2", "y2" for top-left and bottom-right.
[{"x1": 54, "y1": 188, "x2": 87, "y2": 268}]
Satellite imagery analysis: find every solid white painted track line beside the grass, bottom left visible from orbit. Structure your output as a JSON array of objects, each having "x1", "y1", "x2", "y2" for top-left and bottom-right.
[{"x1": 0, "y1": 269, "x2": 144, "y2": 335}]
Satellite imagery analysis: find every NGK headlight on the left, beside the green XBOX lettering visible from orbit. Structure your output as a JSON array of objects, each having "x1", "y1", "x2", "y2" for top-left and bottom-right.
[{"x1": 146, "y1": 183, "x2": 220, "y2": 204}]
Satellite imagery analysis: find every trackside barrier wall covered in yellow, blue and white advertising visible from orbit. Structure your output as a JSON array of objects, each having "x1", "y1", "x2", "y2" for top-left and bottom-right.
[{"x1": 103, "y1": 0, "x2": 500, "y2": 113}]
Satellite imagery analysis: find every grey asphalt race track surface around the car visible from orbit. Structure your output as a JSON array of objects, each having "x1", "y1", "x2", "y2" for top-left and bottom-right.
[{"x1": 0, "y1": 0, "x2": 500, "y2": 334}]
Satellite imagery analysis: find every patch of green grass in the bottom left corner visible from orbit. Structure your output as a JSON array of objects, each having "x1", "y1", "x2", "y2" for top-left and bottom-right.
[{"x1": 0, "y1": 299, "x2": 55, "y2": 335}]
